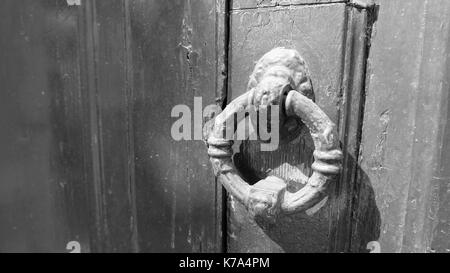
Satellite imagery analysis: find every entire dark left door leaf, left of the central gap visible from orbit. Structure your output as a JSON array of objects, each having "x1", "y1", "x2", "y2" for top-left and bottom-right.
[{"x1": 0, "y1": 0, "x2": 226, "y2": 252}]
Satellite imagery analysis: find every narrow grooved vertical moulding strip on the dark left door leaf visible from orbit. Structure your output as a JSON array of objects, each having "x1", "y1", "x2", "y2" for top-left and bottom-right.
[{"x1": 83, "y1": 0, "x2": 138, "y2": 252}]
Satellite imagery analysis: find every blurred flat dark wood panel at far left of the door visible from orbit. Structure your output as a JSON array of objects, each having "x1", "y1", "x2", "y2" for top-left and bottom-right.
[{"x1": 0, "y1": 0, "x2": 90, "y2": 252}]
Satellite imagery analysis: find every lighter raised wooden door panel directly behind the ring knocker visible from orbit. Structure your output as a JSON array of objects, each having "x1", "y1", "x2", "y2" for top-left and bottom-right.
[{"x1": 228, "y1": 1, "x2": 377, "y2": 252}]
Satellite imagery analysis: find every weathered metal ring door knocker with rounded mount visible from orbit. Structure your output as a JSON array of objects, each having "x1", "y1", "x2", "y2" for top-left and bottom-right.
[{"x1": 207, "y1": 48, "x2": 342, "y2": 221}]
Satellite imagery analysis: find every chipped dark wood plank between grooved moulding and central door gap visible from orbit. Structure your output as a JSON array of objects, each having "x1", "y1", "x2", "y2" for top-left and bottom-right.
[{"x1": 130, "y1": 1, "x2": 224, "y2": 252}]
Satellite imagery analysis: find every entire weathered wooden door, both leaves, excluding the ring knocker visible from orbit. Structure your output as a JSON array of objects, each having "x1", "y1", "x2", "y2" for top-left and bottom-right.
[{"x1": 0, "y1": 0, "x2": 450, "y2": 252}]
